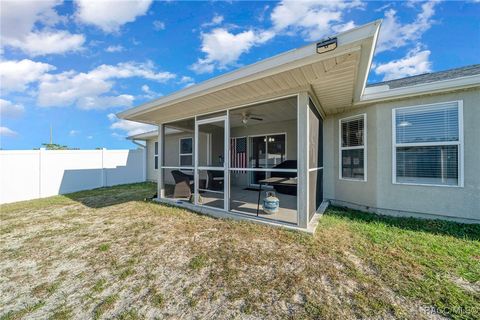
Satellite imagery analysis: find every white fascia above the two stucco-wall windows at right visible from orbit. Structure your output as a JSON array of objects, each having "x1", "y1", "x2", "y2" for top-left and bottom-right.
[{"x1": 355, "y1": 75, "x2": 480, "y2": 105}]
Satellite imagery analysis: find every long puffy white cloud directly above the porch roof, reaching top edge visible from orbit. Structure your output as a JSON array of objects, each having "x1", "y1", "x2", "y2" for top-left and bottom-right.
[{"x1": 190, "y1": 0, "x2": 363, "y2": 73}]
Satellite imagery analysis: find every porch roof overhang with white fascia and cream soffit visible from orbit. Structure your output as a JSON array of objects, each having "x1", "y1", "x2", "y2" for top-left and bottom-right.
[{"x1": 117, "y1": 21, "x2": 380, "y2": 124}]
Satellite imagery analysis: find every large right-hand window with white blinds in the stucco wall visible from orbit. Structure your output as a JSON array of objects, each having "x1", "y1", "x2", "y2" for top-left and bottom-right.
[{"x1": 392, "y1": 101, "x2": 463, "y2": 186}]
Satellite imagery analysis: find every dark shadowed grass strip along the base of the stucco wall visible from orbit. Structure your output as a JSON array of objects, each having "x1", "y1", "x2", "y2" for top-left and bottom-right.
[{"x1": 325, "y1": 206, "x2": 480, "y2": 241}]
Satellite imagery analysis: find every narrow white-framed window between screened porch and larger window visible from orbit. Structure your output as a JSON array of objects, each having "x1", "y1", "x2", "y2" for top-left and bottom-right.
[{"x1": 339, "y1": 114, "x2": 367, "y2": 181}]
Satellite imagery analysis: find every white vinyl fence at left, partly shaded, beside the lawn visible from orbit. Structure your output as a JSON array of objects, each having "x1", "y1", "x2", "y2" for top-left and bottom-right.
[{"x1": 0, "y1": 149, "x2": 146, "y2": 203}]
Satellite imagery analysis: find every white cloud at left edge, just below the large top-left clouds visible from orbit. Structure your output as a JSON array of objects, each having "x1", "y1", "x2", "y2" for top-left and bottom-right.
[{"x1": 0, "y1": 59, "x2": 55, "y2": 94}]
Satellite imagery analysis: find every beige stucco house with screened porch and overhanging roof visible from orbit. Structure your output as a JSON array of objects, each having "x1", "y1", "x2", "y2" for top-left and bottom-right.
[{"x1": 118, "y1": 21, "x2": 480, "y2": 231}]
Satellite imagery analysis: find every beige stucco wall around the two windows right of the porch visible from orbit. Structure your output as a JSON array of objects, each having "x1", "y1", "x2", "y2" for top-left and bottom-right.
[{"x1": 324, "y1": 89, "x2": 480, "y2": 220}]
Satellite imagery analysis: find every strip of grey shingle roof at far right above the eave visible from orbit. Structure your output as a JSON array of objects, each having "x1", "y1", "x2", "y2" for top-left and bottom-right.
[{"x1": 367, "y1": 64, "x2": 480, "y2": 89}]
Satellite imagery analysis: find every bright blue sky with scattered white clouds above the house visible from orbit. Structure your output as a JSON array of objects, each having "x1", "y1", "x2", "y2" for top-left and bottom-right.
[{"x1": 0, "y1": 0, "x2": 480, "y2": 149}]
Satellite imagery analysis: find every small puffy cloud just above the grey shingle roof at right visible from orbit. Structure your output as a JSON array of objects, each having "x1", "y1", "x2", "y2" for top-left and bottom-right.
[{"x1": 374, "y1": 47, "x2": 432, "y2": 81}]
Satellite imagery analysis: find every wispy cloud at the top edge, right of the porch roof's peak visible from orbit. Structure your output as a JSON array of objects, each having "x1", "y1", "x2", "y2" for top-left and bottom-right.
[{"x1": 376, "y1": 1, "x2": 437, "y2": 53}]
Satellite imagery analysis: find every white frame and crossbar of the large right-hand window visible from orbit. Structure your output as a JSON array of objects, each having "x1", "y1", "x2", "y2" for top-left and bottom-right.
[{"x1": 392, "y1": 100, "x2": 464, "y2": 188}]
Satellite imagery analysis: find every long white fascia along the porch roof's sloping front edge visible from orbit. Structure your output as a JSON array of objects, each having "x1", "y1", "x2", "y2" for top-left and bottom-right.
[{"x1": 117, "y1": 20, "x2": 381, "y2": 119}]
